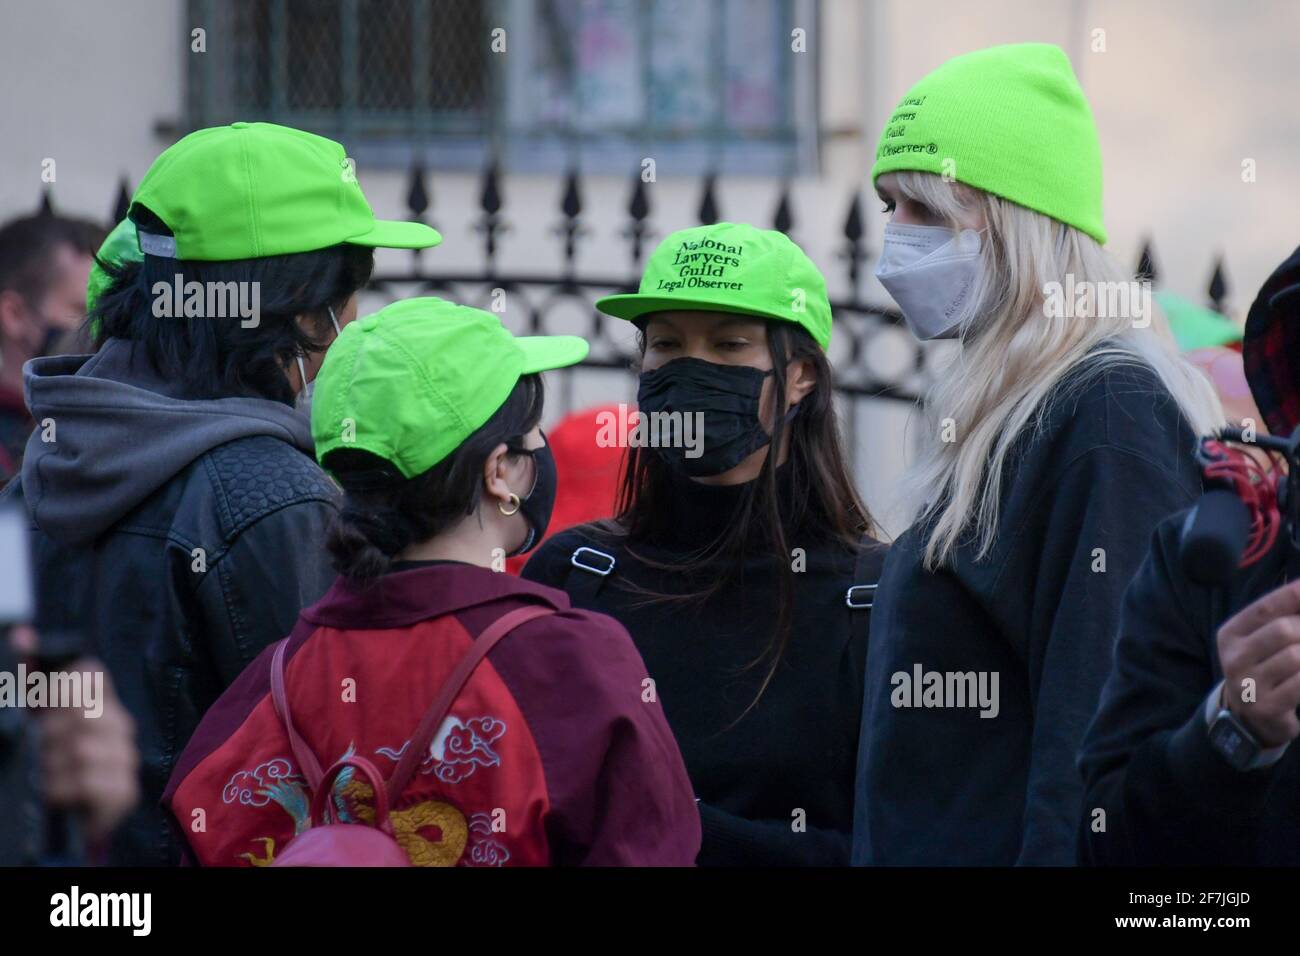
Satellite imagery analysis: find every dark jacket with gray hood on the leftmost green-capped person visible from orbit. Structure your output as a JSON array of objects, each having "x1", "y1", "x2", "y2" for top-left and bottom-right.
[{"x1": 4, "y1": 343, "x2": 337, "y2": 865}]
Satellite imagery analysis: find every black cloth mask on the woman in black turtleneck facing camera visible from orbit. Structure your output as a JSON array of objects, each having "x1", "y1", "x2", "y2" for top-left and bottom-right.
[{"x1": 637, "y1": 358, "x2": 772, "y2": 477}]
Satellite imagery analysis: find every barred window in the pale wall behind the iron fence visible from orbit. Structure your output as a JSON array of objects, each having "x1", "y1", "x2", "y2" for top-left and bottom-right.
[{"x1": 186, "y1": 0, "x2": 816, "y2": 174}]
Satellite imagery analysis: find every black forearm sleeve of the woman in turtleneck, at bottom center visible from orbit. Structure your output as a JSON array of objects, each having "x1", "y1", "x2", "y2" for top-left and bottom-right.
[{"x1": 697, "y1": 801, "x2": 850, "y2": 866}]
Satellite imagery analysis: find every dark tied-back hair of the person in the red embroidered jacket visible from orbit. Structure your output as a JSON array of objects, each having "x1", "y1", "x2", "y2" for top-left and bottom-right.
[{"x1": 330, "y1": 375, "x2": 545, "y2": 587}]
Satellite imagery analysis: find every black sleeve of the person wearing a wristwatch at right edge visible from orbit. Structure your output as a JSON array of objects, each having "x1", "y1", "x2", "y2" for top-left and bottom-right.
[{"x1": 1079, "y1": 516, "x2": 1274, "y2": 865}]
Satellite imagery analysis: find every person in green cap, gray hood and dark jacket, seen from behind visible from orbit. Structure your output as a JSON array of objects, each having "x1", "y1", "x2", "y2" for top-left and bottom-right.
[{"x1": 5, "y1": 122, "x2": 439, "y2": 865}]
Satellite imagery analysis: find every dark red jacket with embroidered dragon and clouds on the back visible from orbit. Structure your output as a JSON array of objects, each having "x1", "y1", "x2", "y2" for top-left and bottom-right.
[{"x1": 163, "y1": 563, "x2": 699, "y2": 866}]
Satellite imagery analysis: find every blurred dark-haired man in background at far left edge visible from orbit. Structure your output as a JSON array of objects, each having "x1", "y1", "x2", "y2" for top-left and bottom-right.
[{"x1": 0, "y1": 212, "x2": 104, "y2": 488}]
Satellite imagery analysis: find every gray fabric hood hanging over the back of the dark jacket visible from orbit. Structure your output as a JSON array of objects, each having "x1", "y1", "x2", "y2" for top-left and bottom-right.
[{"x1": 22, "y1": 338, "x2": 312, "y2": 545}]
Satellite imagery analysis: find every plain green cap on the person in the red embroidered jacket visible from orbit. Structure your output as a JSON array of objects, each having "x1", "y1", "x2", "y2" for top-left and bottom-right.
[{"x1": 312, "y1": 297, "x2": 588, "y2": 477}]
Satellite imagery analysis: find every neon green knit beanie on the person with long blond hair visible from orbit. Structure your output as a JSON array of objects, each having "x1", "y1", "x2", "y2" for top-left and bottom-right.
[{"x1": 871, "y1": 43, "x2": 1106, "y2": 243}]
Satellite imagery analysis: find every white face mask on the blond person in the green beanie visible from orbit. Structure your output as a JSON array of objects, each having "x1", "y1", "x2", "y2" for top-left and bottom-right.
[{"x1": 876, "y1": 222, "x2": 980, "y2": 339}]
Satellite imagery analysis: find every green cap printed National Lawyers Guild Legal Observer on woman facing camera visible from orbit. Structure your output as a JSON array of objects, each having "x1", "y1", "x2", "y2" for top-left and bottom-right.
[{"x1": 595, "y1": 222, "x2": 831, "y2": 349}]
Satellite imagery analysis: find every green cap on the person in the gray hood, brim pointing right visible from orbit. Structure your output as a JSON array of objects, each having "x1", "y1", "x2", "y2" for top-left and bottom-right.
[{"x1": 130, "y1": 122, "x2": 442, "y2": 261}]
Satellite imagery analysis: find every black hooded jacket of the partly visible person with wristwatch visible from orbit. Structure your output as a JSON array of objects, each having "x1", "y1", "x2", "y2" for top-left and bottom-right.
[{"x1": 1079, "y1": 248, "x2": 1300, "y2": 866}]
